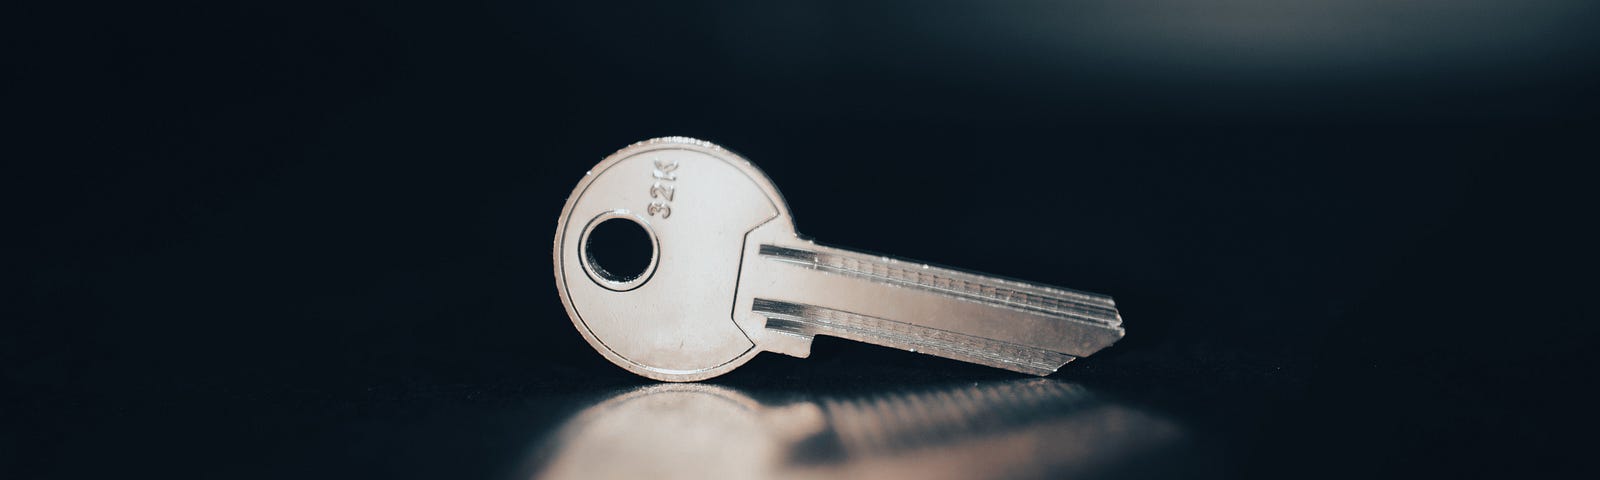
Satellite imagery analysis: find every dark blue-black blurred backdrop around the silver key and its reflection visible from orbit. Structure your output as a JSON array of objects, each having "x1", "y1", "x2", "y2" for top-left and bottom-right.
[{"x1": 0, "y1": 0, "x2": 1600, "y2": 478}]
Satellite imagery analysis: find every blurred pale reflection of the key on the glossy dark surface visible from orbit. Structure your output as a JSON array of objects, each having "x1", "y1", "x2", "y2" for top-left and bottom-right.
[{"x1": 531, "y1": 379, "x2": 1182, "y2": 478}]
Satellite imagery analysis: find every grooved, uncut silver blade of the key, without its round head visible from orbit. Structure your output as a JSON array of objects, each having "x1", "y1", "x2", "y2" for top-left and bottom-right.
[{"x1": 738, "y1": 224, "x2": 1123, "y2": 376}]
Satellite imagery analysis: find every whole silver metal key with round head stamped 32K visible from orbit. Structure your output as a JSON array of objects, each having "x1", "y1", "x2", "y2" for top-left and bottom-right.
[{"x1": 554, "y1": 138, "x2": 1123, "y2": 381}]
